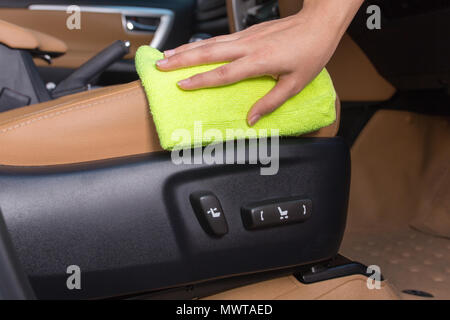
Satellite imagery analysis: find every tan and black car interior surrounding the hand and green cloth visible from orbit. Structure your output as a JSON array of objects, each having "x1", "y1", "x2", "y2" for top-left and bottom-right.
[{"x1": 0, "y1": 0, "x2": 450, "y2": 300}]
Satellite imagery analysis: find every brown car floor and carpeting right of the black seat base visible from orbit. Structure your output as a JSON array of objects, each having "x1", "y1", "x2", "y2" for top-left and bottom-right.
[{"x1": 340, "y1": 110, "x2": 450, "y2": 299}]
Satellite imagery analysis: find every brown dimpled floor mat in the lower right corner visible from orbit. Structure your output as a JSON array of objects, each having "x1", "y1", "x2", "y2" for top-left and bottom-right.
[{"x1": 340, "y1": 226, "x2": 450, "y2": 299}]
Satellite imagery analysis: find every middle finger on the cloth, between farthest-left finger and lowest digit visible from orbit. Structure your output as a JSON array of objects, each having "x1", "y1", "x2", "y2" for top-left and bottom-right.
[{"x1": 178, "y1": 58, "x2": 263, "y2": 90}]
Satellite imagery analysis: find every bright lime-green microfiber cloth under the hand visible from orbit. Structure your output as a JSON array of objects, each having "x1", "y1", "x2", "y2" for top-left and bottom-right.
[{"x1": 135, "y1": 46, "x2": 336, "y2": 150}]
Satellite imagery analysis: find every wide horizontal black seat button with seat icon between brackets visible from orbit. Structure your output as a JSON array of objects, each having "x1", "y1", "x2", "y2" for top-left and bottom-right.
[{"x1": 241, "y1": 199, "x2": 312, "y2": 230}]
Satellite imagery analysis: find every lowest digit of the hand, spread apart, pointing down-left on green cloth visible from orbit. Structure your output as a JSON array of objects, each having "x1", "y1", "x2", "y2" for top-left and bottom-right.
[{"x1": 247, "y1": 75, "x2": 301, "y2": 126}]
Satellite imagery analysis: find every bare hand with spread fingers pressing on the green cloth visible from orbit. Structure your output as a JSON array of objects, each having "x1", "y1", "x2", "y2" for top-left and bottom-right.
[{"x1": 156, "y1": 0, "x2": 362, "y2": 125}]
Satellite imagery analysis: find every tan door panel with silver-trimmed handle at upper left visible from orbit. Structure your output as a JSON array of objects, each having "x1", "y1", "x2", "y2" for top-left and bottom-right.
[{"x1": 0, "y1": 0, "x2": 194, "y2": 68}]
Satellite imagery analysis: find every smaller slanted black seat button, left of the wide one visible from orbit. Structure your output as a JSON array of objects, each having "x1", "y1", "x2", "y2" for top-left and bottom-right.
[{"x1": 189, "y1": 191, "x2": 228, "y2": 237}]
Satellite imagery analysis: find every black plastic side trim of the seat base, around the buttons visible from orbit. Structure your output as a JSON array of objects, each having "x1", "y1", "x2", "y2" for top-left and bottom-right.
[{"x1": 0, "y1": 138, "x2": 350, "y2": 299}]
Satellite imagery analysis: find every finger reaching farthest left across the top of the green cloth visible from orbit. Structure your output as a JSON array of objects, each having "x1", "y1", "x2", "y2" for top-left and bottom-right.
[{"x1": 156, "y1": 41, "x2": 243, "y2": 71}]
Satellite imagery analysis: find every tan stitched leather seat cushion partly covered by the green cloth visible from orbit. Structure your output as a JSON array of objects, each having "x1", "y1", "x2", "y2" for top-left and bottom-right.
[{"x1": 0, "y1": 81, "x2": 340, "y2": 166}]
